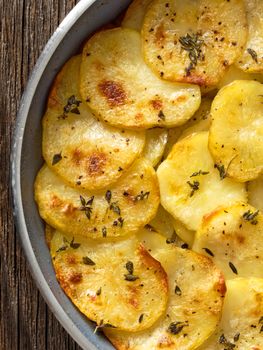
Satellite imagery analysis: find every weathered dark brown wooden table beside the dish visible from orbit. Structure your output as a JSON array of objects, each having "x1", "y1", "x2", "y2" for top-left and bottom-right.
[{"x1": 0, "y1": 0, "x2": 80, "y2": 350}]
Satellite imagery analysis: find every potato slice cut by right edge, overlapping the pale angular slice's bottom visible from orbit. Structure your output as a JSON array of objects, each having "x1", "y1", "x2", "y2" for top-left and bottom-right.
[{"x1": 192, "y1": 203, "x2": 263, "y2": 279}]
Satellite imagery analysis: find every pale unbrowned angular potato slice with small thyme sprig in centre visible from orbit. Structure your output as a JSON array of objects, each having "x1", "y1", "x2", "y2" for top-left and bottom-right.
[{"x1": 157, "y1": 132, "x2": 246, "y2": 231}]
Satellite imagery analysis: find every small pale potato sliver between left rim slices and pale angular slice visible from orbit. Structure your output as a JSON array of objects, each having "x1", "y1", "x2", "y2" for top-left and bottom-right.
[{"x1": 142, "y1": 128, "x2": 168, "y2": 167}]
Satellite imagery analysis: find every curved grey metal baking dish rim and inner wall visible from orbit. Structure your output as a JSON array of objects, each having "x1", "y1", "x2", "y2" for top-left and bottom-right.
[{"x1": 11, "y1": 0, "x2": 130, "y2": 350}]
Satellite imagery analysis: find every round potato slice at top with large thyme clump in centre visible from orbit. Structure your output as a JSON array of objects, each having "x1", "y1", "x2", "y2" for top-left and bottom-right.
[{"x1": 142, "y1": 0, "x2": 247, "y2": 86}]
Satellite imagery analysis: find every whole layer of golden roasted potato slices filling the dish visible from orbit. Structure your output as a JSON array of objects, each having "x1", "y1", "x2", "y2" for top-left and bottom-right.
[{"x1": 35, "y1": 0, "x2": 263, "y2": 350}]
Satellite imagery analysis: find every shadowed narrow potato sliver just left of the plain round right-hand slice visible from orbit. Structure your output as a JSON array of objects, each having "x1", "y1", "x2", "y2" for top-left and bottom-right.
[{"x1": 164, "y1": 97, "x2": 212, "y2": 158}]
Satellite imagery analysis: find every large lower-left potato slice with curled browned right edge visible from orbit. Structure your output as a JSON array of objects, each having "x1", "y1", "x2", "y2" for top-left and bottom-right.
[{"x1": 51, "y1": 231, "x2": 168, "y2": 332}]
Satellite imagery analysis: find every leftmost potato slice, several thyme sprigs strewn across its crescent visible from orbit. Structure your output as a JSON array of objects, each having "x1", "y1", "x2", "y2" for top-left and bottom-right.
[{"x1": 35, "y1": 159, "x2": 159, "y2": 238}]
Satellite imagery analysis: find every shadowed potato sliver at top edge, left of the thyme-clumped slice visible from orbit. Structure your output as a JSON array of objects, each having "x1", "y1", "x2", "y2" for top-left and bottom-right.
[{"x1": 121, "y1": 0, "x2": 152, "y2": 32}]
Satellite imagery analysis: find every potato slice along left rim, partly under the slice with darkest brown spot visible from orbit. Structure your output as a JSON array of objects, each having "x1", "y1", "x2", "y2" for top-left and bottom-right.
[{"x1": 43, "y1": 56, "x2": 145, "y2": 190}]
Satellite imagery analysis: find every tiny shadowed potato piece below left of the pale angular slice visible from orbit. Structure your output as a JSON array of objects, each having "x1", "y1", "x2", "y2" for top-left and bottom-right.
[{"x1": 147, "y1": 205, "x2": 174, "y2": 238}]
